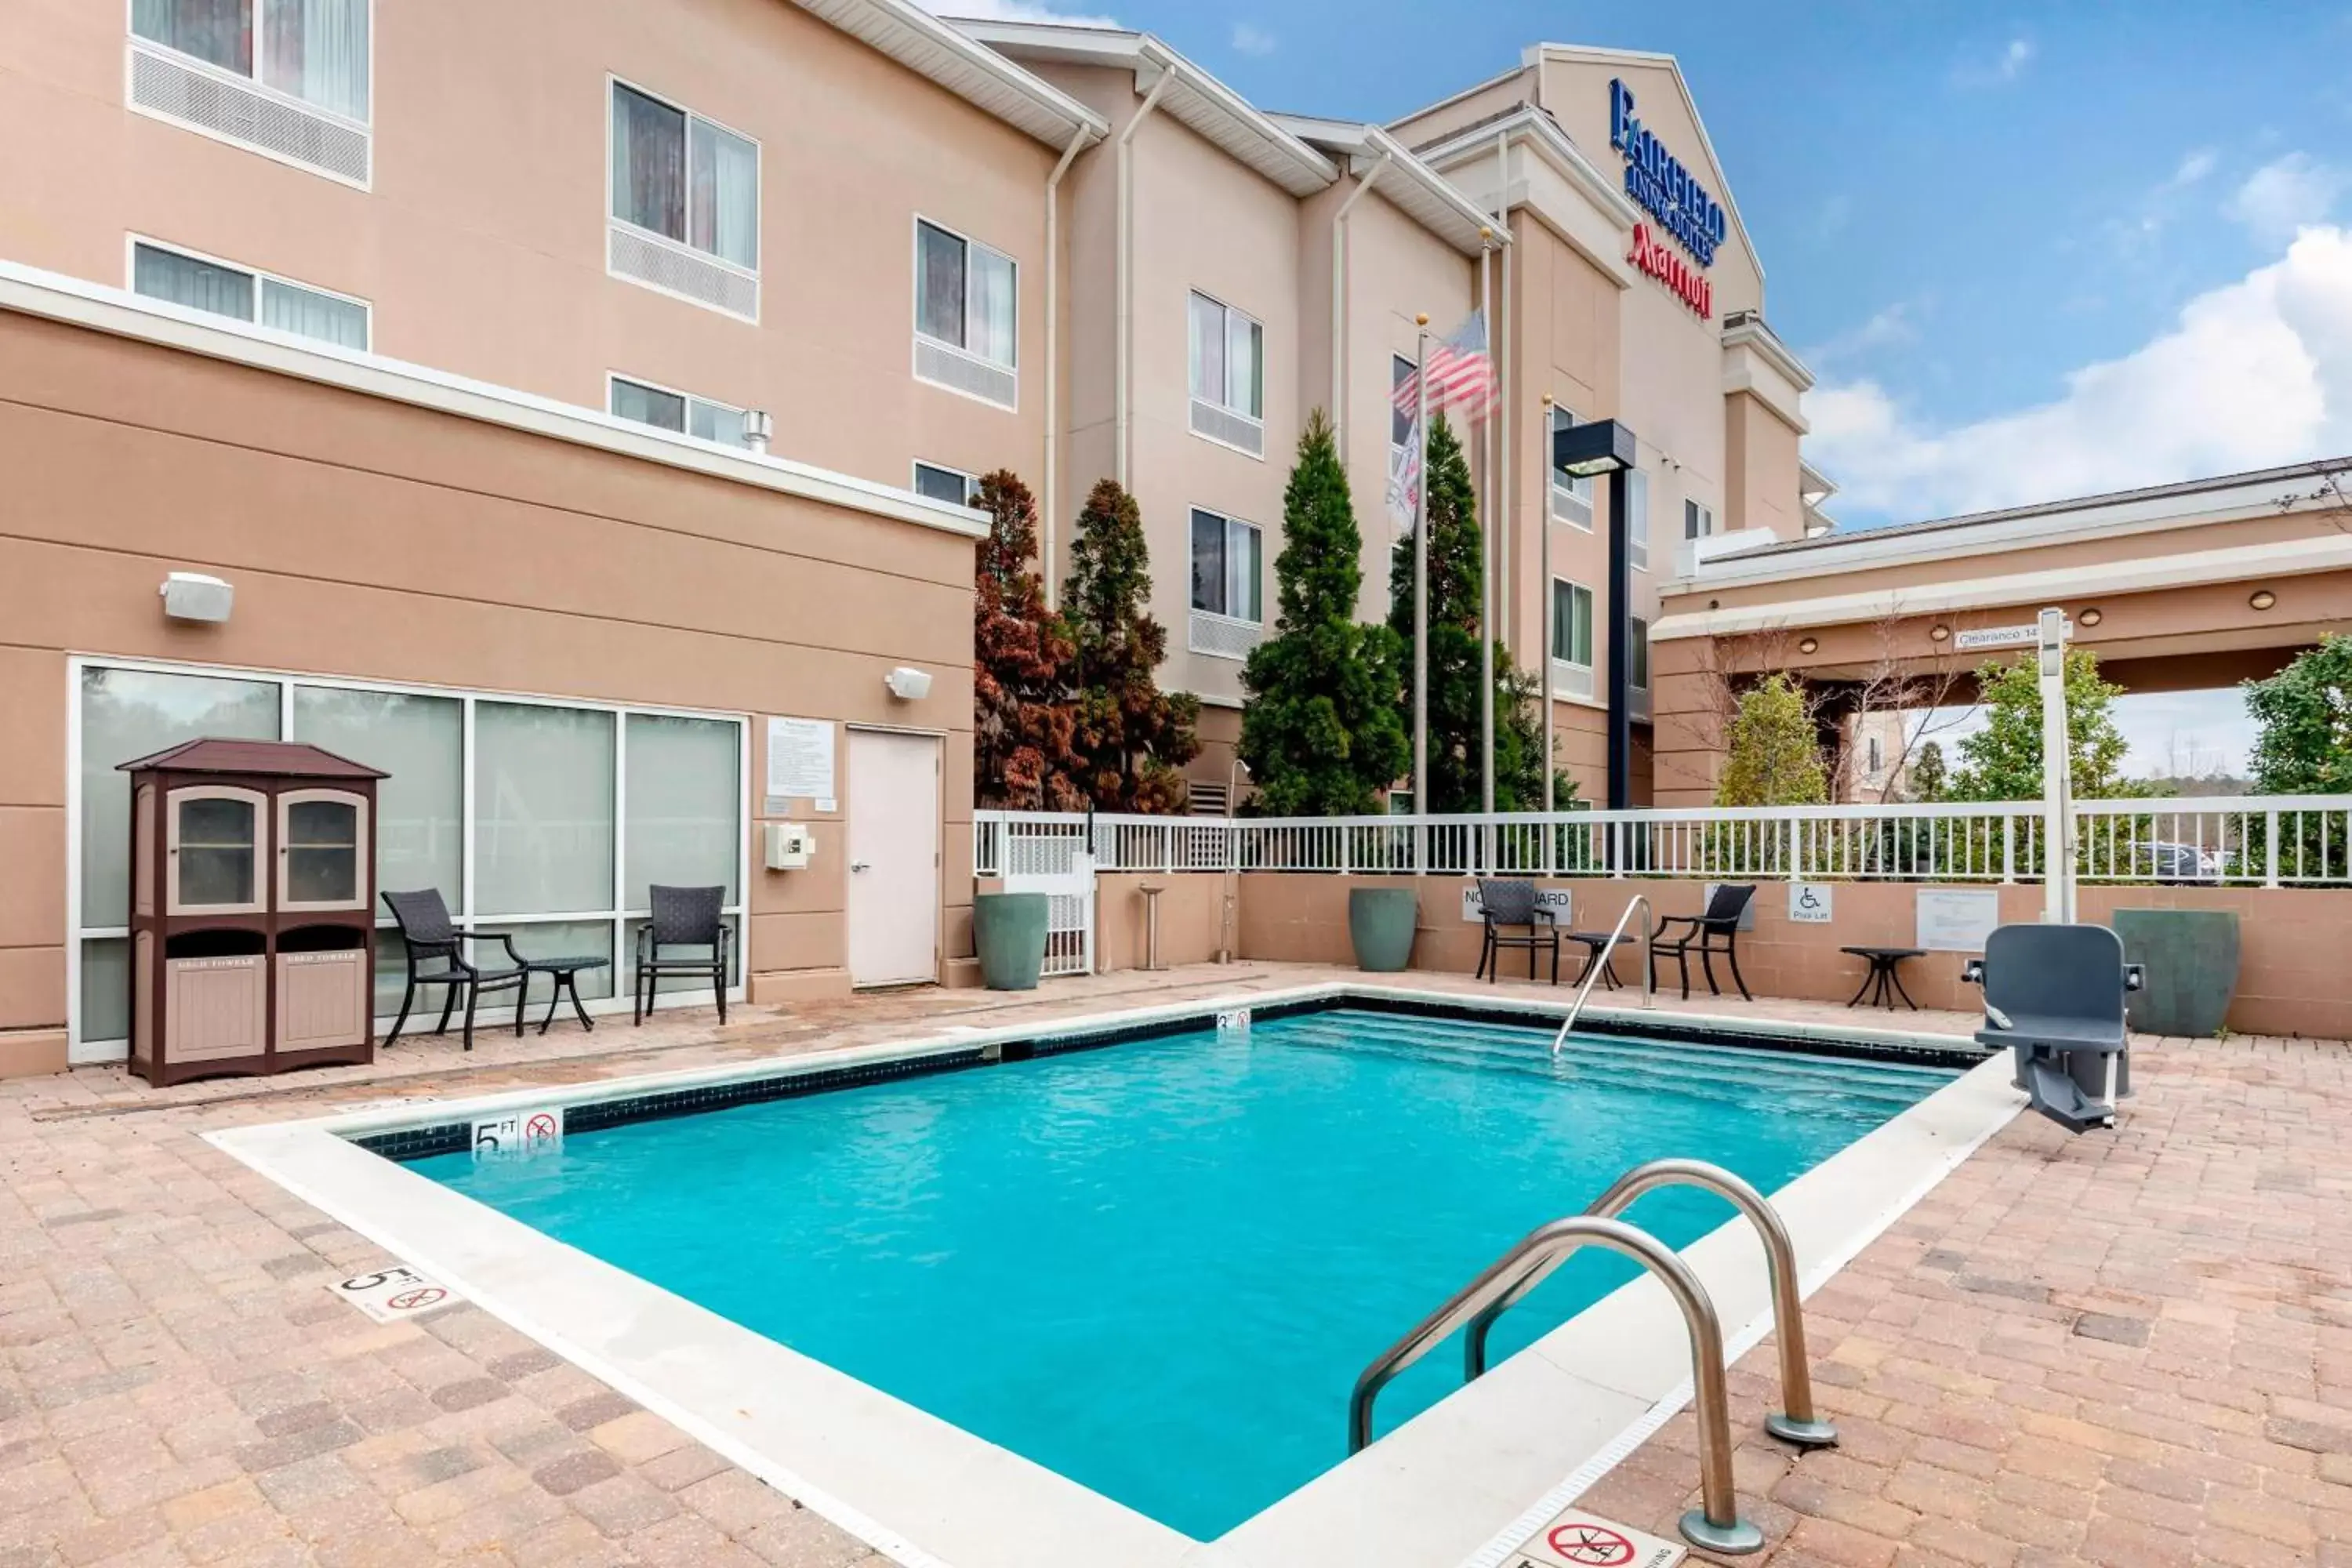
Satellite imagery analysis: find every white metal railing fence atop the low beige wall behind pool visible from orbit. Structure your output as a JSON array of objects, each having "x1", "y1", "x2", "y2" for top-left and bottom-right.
[{"x1": 974, "y1": 794, "x2": 2352, "y2": 886}]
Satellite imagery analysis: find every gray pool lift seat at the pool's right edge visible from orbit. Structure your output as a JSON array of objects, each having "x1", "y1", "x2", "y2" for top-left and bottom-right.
[{"x1": 1966, "y1": 926, "x2": 2140, "y2": 1133}]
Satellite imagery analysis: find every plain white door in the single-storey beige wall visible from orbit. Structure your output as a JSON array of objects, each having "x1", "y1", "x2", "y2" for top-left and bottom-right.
[{"x1": 849, "y1": 729, "x2": 938, "y2": 985}]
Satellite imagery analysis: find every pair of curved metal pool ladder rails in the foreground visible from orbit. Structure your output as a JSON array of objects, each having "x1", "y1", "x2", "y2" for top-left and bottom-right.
[{"x1": 1348, "y1": 1159, "x2": 1837, "y2": 1554}]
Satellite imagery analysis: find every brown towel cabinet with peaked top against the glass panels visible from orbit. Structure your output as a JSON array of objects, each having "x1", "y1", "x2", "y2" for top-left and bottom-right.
[{"x1": 122, "y1": 741, "x2": 383, "y2": 1083}]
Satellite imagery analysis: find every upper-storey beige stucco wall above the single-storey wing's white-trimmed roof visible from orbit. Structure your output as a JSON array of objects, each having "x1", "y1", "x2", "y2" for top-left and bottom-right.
[{"x1": 0, "y1": 0, "x2": 1054, "y2": 487}]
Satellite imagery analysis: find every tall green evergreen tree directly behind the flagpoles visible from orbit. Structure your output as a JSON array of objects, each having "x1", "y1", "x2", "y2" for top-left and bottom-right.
[{"x1": 1388, "y1": 414, "x2": 1573, "y2": 813}]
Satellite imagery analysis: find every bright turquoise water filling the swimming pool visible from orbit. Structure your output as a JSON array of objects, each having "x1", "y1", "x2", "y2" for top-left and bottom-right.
[{"x1": 414, "y1": 1008, "x2": 1955, "y2": 1540}]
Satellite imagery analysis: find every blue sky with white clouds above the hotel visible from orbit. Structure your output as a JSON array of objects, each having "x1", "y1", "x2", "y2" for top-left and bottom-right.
[{"x1": 936, "y1": 0, "x2": 2352, "y2": 771}]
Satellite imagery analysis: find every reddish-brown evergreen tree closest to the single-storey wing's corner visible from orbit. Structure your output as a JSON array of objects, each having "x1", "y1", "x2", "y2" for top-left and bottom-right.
[{"x1": 971, "y1": 468, "x2": 1087, "y2": 811}]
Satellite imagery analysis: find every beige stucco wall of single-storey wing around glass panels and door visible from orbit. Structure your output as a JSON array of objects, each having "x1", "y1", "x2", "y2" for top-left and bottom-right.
[{"x1": 0, "y1": 313, "x2": 971, "y2": 1072}]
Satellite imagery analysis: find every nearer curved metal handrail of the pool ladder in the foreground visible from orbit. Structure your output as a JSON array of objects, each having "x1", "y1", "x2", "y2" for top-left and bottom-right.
[{"x1": 1348, "y1": 1215, "x2": 1764, "y2": 1552}]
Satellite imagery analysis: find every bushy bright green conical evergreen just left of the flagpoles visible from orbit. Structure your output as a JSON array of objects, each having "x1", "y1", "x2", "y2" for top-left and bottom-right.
[{"x1": 1242, "y1": 409, "x2": 1411, "y2": 815}]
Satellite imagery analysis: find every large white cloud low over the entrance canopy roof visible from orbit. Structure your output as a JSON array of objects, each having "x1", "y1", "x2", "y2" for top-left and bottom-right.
[{"x1": 1804, "y1": 228, "x2": 2352, "y2": 520}]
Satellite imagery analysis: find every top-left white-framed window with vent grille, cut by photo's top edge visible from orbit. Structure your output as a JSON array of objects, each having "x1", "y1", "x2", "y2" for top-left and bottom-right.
[{"x1": 129, "y1": 0, "x2": 372, "y2": 186}]
